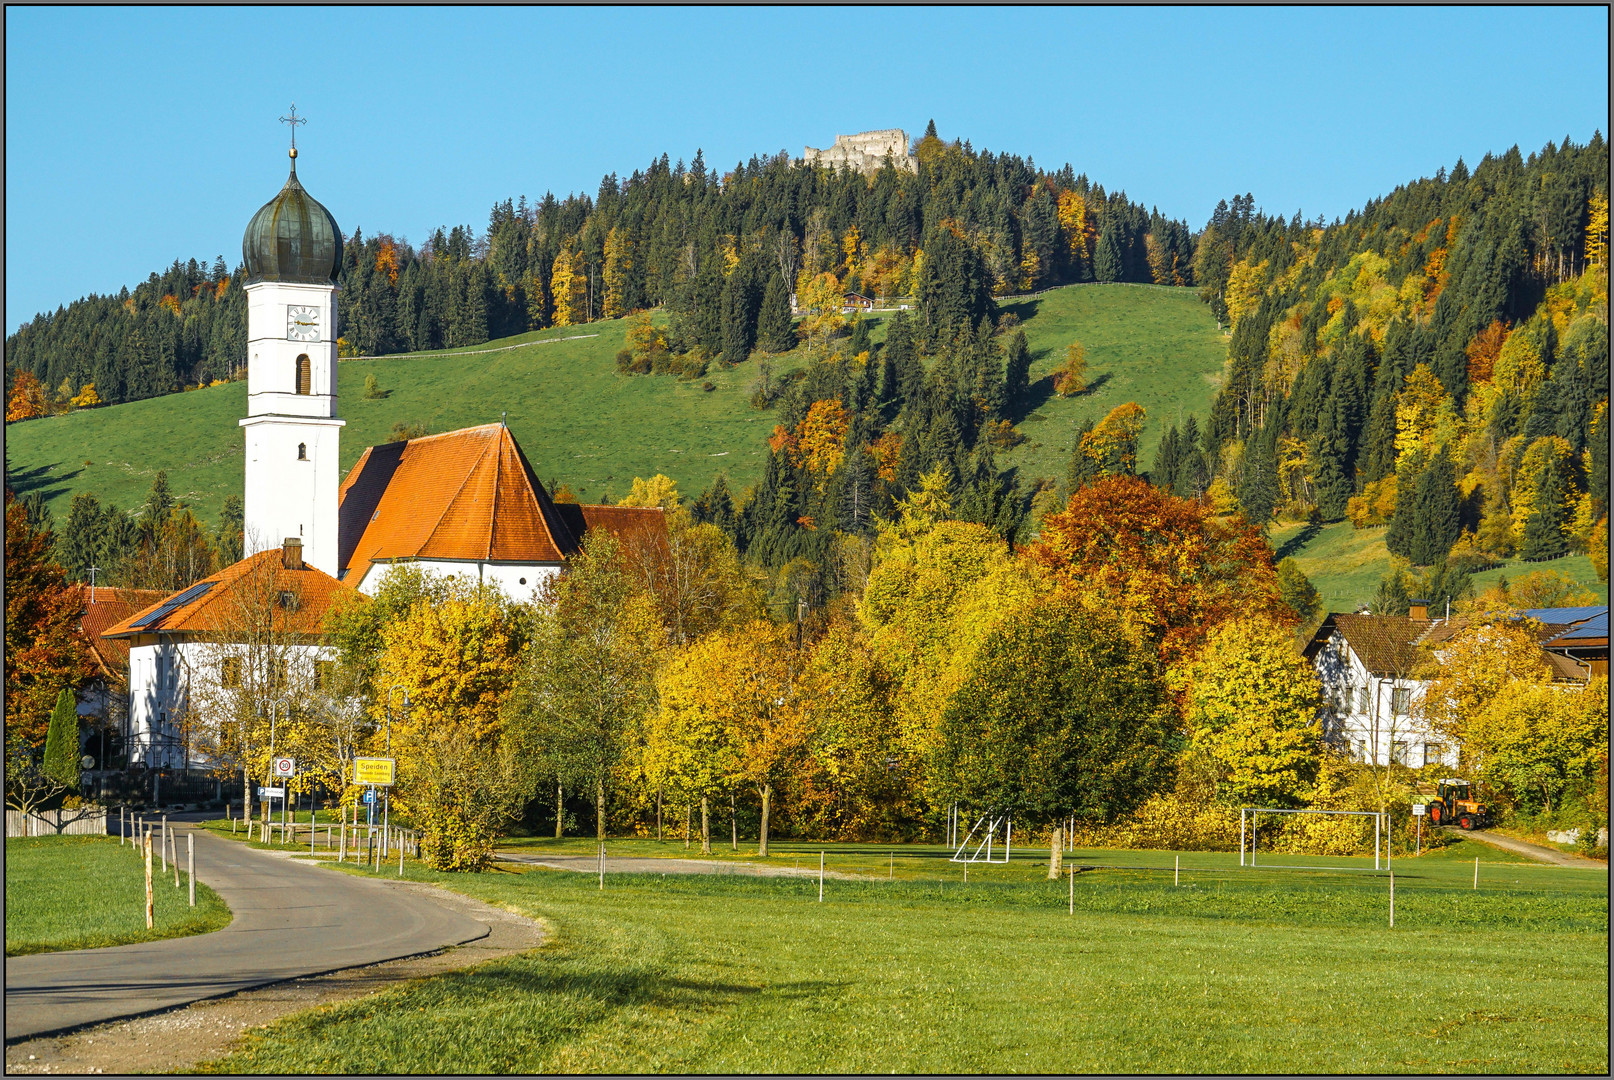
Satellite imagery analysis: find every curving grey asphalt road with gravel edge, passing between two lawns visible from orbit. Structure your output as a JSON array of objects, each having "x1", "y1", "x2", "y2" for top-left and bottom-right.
[{"x1": 5, "y1": 827, "x2": 489, "y2": 1043}]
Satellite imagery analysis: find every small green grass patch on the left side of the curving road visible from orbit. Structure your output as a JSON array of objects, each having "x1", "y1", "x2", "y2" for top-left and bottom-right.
[{"x1": 5, "y1": 836, "x2": 229, "y2": 956}]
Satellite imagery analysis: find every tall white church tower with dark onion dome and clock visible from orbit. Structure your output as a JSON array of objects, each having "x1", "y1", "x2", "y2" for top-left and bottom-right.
[{"x1": 240, "y1": 123, "x2": 344, "y2": 576}]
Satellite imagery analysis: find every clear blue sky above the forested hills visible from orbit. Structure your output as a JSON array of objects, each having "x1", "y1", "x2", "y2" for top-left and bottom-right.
[{"x1": 5, "y1": 8, "x2": 1609, "y2": 333}]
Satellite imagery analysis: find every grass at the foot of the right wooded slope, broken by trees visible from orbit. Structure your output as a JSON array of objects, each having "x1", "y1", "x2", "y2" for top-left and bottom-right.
[{"x1": 1272, "y1": 521, "x2": 1609, "y2": 612}]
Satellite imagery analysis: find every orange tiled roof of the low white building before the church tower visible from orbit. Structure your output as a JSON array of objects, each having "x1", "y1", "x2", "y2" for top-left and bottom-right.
[{"x1": 102, "y1": 547, "x2": 358, "y2": 639}]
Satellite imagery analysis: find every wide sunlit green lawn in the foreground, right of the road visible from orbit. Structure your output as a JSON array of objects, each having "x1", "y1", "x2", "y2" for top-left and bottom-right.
[{"x1": 195, "y1": 839, "x2": 1608, "y2": 1074}]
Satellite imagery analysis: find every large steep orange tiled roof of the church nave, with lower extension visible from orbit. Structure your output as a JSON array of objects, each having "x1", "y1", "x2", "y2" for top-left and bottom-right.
[{"x1": 337, "y1": 425, "x2": 667, "y2": 586}]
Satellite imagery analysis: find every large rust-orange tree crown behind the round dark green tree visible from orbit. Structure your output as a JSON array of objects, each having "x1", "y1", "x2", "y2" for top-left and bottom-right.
[{"x1": 1027, "y1": 476, "x2": 1294, "y2": 663}]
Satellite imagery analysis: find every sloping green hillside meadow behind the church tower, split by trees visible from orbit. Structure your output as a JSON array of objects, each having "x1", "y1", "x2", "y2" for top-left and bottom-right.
[{"x1": 6, "y1": 286, "x2": 1225, "y2": 523}]
